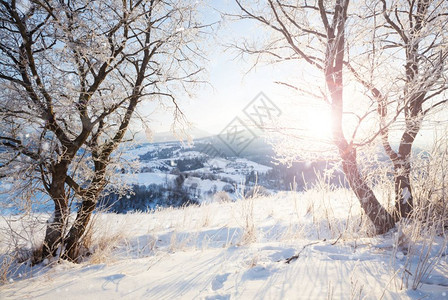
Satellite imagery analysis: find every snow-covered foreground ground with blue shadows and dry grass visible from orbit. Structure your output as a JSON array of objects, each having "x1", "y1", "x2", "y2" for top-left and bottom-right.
[{"x1": 0, "y1": 190, "x2": 448, "y2": 300}]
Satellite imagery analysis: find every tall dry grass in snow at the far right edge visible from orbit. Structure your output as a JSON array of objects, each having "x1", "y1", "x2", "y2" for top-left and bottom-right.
[{"x1": 388, "y1": 137, "x2": 448, "y2": 290}]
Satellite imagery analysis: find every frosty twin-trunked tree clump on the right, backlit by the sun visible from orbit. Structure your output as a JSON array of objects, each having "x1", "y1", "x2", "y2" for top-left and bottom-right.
[{"x1": 234, "y1": 0, "x2": 448, "y2": 233}]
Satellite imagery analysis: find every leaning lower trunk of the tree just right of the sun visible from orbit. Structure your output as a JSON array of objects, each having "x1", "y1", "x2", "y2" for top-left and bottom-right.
[{"x1": 340, "y1": 147, "x2": 395, "y2": 234}]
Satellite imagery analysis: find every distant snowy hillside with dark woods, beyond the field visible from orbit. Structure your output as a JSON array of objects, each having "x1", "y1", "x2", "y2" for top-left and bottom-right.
[{"x1": 103, "y1": 137, "x2": 345, "y2": 213}]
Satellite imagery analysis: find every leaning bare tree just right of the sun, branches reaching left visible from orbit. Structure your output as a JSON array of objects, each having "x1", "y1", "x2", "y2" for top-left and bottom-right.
[{"x1": 229, "y1": 0, "x2": 395, "y2": 234}]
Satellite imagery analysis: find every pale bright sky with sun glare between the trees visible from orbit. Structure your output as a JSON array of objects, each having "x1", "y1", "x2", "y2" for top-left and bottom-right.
[{"x1": 135, "y1": 0, "x2": 448, "y2": 150}]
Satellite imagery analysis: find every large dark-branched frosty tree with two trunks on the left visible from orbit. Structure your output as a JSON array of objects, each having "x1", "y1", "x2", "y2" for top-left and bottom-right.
[{"x1": 0, "y1": 0, "x2": 208, "y2": 260}]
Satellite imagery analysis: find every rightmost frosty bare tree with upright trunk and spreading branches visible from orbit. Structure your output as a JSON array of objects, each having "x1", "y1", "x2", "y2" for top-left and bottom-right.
[{"x1": 346, "y1": 0, "x2": 448, "y2": 220}]
